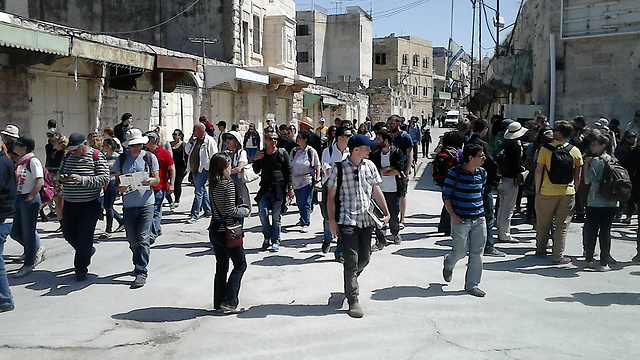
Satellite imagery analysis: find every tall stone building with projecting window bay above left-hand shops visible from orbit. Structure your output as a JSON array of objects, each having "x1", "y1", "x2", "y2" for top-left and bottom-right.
[{"x1": 0, "y1": 0, "x2": 313, "y2": 127}]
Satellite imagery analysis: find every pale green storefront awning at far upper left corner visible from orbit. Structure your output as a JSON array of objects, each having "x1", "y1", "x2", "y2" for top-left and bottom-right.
[{"x1": 0, "y1": 24, "x2": 71, "y2": 56}]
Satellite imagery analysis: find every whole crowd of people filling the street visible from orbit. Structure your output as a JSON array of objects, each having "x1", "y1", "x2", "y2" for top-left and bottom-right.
[{"x1": 0, "y1": 112, "x2": 640, "y2": 317}]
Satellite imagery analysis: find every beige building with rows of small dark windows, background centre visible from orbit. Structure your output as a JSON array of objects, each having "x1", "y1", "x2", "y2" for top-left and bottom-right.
[{"x1": 369, "y1": 34, "x2": 433, "y2": 119}]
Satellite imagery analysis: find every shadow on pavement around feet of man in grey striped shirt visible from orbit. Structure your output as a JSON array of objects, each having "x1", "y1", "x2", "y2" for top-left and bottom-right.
[{"x1": 9, "y1": 268, "x2": 133, "y2": 296}]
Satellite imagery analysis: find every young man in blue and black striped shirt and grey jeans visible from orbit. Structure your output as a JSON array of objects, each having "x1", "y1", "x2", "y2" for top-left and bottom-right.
[{"x1": 442, "y1": 144, "x2": 487, "y2": 297}]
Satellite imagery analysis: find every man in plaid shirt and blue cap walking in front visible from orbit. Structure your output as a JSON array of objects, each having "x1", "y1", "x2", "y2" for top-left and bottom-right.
[{"x1": 327, "y1": 134, "x2": 389, "y2": 318}]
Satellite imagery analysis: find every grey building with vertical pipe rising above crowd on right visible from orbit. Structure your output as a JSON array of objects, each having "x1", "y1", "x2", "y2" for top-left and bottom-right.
[{"x1": 470, "y1": 0, "x2": 640, "y2": 128}]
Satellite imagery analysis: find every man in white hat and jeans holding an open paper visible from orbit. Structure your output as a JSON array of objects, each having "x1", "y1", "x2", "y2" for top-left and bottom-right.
[{"x1": 114, "y1": 128, "x2": 160, "y2": 289}]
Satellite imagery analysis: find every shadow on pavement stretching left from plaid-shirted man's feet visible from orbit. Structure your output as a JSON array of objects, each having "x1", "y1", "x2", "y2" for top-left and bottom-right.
[{"x1": 238, "y1": 293, "x2": 346, "y2": 319}]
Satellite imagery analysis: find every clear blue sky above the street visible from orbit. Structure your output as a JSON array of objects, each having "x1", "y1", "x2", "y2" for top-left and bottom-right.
[{"x1": 296, "y1": 0, "x2": 521, "y2": 57}]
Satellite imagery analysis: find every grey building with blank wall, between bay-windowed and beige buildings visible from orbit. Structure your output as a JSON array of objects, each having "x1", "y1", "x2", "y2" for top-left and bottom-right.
[{"x1": 296, "y1": 6, "x2": 373, "y2": 89}]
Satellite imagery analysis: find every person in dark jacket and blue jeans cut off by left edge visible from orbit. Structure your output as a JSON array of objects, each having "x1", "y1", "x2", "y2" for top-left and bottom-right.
[{"x1": 0, "y1": 147, "x2": 17, "y2": 312}]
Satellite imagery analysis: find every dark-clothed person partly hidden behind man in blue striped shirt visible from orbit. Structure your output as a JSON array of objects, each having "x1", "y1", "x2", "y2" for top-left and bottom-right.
[{"x1": 467, "y1": 119, "x2": 506, "y2": 257}]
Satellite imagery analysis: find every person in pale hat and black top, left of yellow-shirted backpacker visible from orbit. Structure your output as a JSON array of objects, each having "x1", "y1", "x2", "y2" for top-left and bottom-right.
[{"x1": 496, "y1": 121, "x2": 528, "y2": 242}]
